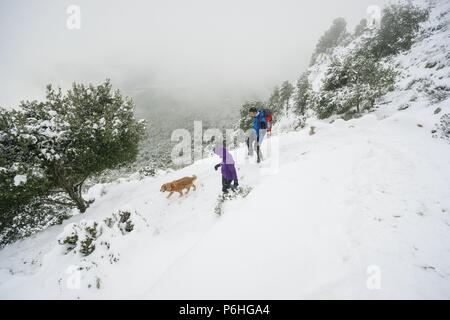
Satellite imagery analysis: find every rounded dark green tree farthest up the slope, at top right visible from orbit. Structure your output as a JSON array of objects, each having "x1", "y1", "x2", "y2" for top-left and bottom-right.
[{"x1": 367, "y1": 2, "x2": 429, "y2": 59}]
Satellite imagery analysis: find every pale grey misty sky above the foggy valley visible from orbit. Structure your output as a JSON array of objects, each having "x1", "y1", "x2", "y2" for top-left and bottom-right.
[{"x1": 0, "y1": 0, "x2": 387, "y2": 117}]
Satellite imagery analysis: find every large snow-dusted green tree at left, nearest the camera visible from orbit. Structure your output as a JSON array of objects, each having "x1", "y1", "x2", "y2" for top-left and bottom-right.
[{"x1": 0, "y1": 80, "x2": 145, "y2": 245}]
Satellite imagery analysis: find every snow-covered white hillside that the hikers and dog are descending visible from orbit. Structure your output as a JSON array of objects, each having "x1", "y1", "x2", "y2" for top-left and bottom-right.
[{"x1": 0, "y1": 1, "x2": 450, "y2": 299}]
